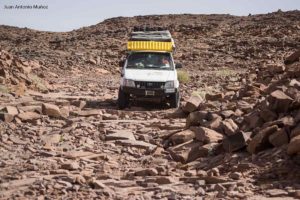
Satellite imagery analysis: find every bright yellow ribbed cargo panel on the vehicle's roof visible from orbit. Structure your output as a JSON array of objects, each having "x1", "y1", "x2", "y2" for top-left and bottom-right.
[{"x1": 127, "y1": 41, "x2": 173, "y2": 52}]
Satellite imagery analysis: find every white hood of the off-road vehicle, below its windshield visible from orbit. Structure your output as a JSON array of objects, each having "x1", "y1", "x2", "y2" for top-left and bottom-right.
[{"x1": 124, "y1": 69, "x2": 176, "y2": 82}]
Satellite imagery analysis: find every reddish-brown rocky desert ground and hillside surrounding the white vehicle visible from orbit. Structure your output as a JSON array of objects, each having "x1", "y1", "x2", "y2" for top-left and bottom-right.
[{"x1": 0, "y1": 11, "x2": 300, "y2": 199}]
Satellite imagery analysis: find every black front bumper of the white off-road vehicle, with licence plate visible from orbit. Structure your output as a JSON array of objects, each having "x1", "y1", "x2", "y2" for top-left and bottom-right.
[{"x1": 123, "y1": 87, "x2": 177, "y2": 98}]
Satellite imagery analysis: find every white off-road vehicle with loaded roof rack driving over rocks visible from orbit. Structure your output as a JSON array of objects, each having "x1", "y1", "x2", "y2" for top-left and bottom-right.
[{"x1": 118, "y1": 30, "x2": 182, "y2": 109}]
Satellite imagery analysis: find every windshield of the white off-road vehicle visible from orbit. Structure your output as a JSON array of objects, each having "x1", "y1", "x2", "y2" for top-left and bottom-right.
[{"x1": 127, "y1": 52, "x2": 173, "y2": 70}]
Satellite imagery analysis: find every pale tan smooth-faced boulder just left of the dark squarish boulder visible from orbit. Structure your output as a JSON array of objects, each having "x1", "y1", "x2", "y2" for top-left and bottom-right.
[{"x1": 190, "y1": 126, "x2": 224, "y2": 144}]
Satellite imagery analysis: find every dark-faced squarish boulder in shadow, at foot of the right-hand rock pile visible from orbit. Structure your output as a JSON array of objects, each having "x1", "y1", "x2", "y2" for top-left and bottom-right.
[{"x1": 222, "y1": 131, "x2": 251, "y2": 152}]
